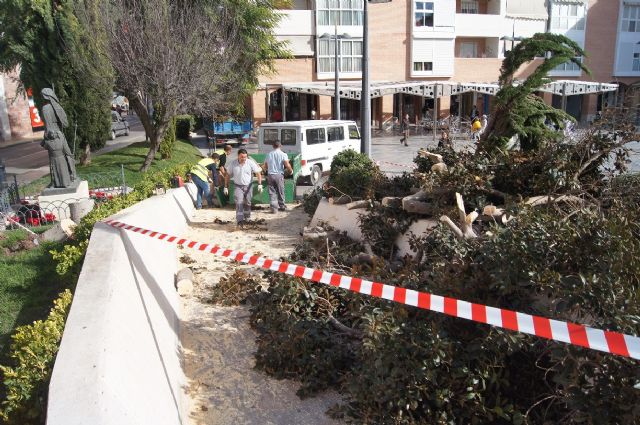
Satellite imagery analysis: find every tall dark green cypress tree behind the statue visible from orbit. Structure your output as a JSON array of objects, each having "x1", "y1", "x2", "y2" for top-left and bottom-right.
[{"x1": 0, "y1": 0, "x2": 113, "y2": 163}]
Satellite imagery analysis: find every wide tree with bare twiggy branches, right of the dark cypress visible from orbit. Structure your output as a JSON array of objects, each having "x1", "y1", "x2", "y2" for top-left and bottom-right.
[{"x1": 78, "y1": 0, "x2": 287, "y2": 171}]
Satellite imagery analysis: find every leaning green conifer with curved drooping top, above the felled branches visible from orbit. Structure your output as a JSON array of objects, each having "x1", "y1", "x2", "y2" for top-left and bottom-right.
[{"x1": 480, "y1": 33, "x2": 589, "y2": 151}]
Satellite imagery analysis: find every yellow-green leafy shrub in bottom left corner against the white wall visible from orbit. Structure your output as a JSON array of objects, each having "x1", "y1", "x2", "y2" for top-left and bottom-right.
[{"x1": 0, "y1": 290, "x2": 71, "y2": 425}]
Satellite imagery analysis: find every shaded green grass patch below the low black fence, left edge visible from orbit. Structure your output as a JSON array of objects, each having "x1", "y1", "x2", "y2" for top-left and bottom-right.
[{"x1": 0, "y1": 228, "x2": 69, "y2": 364}]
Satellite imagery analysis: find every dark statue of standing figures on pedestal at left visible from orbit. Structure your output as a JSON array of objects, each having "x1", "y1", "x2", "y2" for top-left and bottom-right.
[{"x1": 40, "y1": 88, "x2": 76, "y2": 188}]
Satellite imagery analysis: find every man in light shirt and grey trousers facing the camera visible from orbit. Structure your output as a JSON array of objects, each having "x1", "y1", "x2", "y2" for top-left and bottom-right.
[{"x1": 224, "y1": 148, "x2": 262, "y2": 228}]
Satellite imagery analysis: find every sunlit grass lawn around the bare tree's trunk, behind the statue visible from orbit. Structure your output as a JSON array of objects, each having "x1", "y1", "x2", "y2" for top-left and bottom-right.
[{"x1": 20, "y1": 140, "x2": 202, "y2": 196}]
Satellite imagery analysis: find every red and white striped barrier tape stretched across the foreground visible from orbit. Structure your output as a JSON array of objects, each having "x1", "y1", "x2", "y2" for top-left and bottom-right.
[{"x1": 105, "y1": 220, "x2": 640, "y2": 360}]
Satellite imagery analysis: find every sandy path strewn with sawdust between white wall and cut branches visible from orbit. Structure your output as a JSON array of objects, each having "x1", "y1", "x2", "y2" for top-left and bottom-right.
[{"x1": 179, "y1": 206, "x2": 340, "y2": 425}]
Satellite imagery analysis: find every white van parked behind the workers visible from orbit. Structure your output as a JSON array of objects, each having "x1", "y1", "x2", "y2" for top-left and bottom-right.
[{"x1": 258, "y1": 120, "x2": 360, "y2": 185}]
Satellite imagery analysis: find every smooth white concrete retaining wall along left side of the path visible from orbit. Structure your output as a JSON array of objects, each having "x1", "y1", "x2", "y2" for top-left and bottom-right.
[{"x1": 47, "y1": 188, "x2": 194, "y2": 425}]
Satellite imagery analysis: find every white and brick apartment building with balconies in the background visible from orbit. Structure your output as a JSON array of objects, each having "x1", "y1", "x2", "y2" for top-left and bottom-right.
[{"x1": 251, "y1": 0, "x2": 640, "y2": 125}]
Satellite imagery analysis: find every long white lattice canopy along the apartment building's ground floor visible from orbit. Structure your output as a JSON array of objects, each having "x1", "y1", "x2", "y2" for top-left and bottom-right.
[{"x1": 272, "y1": 80, "x2": 618, "y2": 100}]
